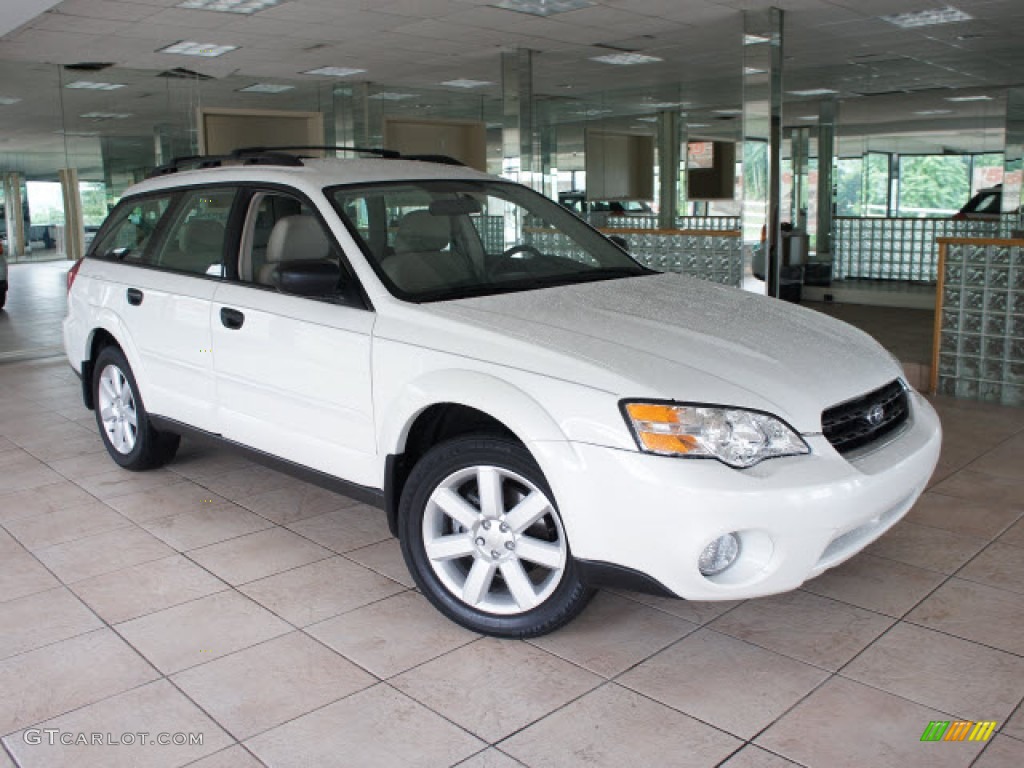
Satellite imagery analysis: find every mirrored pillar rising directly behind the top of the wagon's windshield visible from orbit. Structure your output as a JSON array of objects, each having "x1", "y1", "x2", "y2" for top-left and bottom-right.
[{"x1": 502, "y1": 48, "x2": 544, "y2": 191}]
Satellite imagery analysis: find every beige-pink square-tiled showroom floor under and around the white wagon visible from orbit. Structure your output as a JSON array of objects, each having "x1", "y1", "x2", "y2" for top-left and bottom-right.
[{"x1": 0, "y1": 360, "x2": 1024, "y2": 768}]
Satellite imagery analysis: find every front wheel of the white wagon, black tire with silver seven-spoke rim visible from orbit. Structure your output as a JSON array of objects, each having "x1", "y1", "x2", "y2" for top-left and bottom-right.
[{"x1": 398, "y1": 436, "x2": 592, "y2": 638}]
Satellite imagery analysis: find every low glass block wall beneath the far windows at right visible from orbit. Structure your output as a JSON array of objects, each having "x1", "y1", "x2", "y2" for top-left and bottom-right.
[{"x1": 833, "y1": 217, "x2": 1001, "y2": 283}]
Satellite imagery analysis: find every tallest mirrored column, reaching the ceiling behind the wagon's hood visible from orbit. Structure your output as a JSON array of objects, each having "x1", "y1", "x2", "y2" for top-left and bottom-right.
[{"x1": 741, "y1": 8, "x2": 783, "y2": 296}]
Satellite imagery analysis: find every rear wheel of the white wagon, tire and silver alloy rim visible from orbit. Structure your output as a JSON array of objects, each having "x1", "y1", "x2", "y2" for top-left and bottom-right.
[{"x1": 92, "y1": 346, "x2": 181, "y2": 472}]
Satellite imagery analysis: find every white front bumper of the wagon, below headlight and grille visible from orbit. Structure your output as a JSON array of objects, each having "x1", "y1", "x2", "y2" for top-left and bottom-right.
[{"x1": 535, "y1": 393, "x2": 942, "y2": 600}]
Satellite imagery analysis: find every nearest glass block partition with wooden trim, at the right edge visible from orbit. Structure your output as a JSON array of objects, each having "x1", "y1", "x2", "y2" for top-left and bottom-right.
[{"x1": 933, "y1": 240, "x2": 1024, "y2": 406}]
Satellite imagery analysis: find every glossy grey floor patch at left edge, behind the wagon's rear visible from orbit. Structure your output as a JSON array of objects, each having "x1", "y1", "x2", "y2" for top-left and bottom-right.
[{"x1": 0, "y1": 261, "x2": 71, "y2": 360}]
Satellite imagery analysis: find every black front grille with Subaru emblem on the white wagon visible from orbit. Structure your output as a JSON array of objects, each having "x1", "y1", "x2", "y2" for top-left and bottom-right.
[{"x1": 821, "y1": 379, "x2": 910, "y2": 454}]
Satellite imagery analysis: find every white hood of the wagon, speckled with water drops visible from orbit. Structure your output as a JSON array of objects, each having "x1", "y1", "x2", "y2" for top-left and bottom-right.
[{"x1": 421, "y1": 274, "x2": 902, "y2": 433}]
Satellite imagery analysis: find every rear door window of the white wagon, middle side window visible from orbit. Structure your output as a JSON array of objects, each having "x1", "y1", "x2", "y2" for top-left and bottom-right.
[{"x1": 151, "y1": 187, "x2": 237, "y2": 278}]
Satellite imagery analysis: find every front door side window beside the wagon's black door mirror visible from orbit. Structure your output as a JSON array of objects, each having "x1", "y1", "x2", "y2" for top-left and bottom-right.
[{"x1": 239, "y1": 191, "x2": 357, "y2": 303}]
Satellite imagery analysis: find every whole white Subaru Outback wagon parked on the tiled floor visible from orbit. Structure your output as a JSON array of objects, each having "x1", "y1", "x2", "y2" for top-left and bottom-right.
[{"x1": 63, "y1": 151, "x2": 941, "y2": 637}]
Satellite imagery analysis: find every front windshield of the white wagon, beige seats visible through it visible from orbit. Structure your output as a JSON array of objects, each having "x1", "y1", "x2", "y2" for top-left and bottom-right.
[{"x1": 328, "y1": 180, "x2": 649, "y2": 302}]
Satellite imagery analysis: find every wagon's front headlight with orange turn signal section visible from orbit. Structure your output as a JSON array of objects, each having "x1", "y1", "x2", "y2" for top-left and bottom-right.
[{"x1": 624, "y1": 402, "x2": 811, "y2": 469}]
